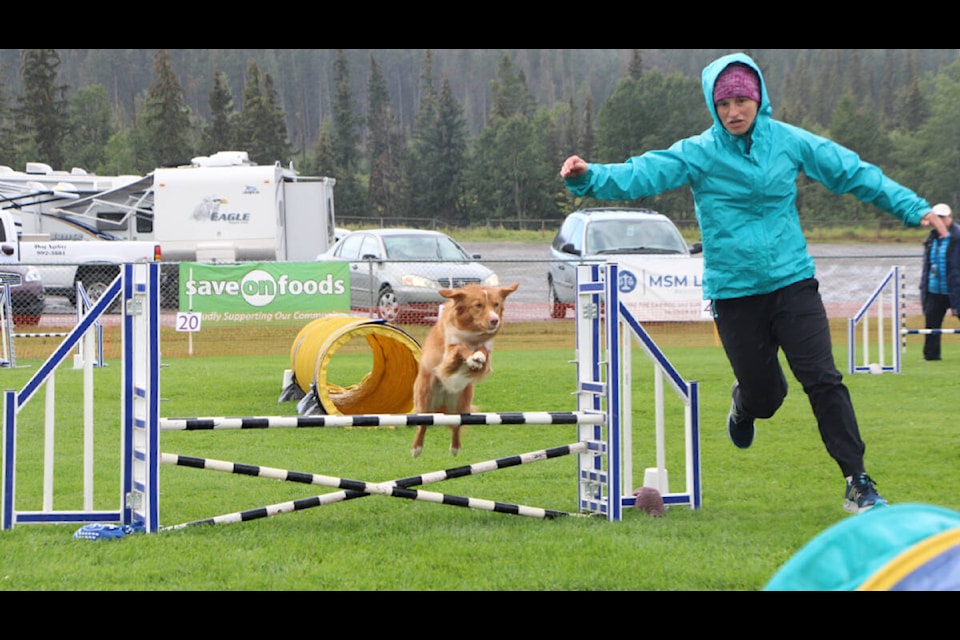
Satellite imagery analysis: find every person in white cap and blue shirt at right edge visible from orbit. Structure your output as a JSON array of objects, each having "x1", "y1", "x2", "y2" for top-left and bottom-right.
[{"x1": 920, "y1": 204, "x2": 960, "y2": 360}]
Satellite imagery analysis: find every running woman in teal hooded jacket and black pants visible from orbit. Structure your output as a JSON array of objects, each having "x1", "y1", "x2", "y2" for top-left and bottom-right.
[{"x1": 560, "y1": 53, "x2": 946, "y2": 513}]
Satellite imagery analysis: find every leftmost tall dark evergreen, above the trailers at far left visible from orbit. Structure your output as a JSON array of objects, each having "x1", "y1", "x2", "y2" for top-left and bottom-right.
[{"x1": 16, "y1": 49, "x2": 69, "y2": 169}]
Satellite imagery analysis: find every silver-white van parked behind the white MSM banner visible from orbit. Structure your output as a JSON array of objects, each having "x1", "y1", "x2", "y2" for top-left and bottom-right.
[{"x1": 547, "y1": 208, "x2": 703, "y2": 318}]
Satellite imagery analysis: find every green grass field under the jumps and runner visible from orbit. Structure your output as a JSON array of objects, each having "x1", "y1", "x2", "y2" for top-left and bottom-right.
[{"x1": 0, "y1": 335, "x2": 960, "y2": 591}]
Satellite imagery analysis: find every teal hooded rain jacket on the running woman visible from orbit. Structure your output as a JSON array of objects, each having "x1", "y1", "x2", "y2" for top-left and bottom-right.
[{"x1": 566, "y1": 53, "x2": 930, "y2": 300}]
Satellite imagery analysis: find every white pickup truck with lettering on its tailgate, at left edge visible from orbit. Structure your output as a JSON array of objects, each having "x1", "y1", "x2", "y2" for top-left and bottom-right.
[{"x1": 0, "y1": 211, "x2": 163, "y2": 303}]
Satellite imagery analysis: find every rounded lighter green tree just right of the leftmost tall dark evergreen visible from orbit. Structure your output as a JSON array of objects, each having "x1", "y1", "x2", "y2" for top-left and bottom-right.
[{"x1": 64, "y1": 84, "x2": 115, "y2": 173}]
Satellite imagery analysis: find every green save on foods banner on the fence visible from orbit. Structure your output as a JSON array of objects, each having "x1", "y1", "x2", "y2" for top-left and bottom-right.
[{"x1": 180, "y1": 262, "x2": 350, "y2": 313}]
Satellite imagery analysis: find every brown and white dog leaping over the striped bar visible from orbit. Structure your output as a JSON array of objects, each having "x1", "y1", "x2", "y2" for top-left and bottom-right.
[{"x1": 410, "y1": 282, "x2": 520, "y2": 458}]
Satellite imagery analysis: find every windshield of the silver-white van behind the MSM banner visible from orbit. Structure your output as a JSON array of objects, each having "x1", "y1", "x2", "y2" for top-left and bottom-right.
[{"x1": 584, "y1": 220, "x2": 687, "y2": 255}]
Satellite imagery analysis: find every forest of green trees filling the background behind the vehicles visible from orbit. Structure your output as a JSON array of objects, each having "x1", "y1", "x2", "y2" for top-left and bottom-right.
[{"x1": 0, "y1": 49, "x2": 960, "y2": 226}]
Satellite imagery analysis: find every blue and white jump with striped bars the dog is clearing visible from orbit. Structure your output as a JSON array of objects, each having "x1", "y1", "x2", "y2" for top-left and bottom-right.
[{"x1": 0, "y1": 263, "x2": 701, "y2": 533}]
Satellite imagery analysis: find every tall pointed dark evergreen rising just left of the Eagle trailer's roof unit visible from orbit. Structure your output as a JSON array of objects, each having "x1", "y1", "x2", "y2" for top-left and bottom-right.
[{"x1": 140, "y1": 49, "x2": 194, "y2": 170}]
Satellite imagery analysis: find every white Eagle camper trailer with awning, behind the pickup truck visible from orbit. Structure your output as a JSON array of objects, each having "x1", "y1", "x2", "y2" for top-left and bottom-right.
[{"x1": 0, "y1": 151, "x2": 336, "y2": 304}]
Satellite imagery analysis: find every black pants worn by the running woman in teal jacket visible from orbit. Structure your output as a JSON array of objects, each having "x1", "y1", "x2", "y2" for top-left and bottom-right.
[{"x1": 713, "y1": 278, "x2": 866, "y2": 477}]
